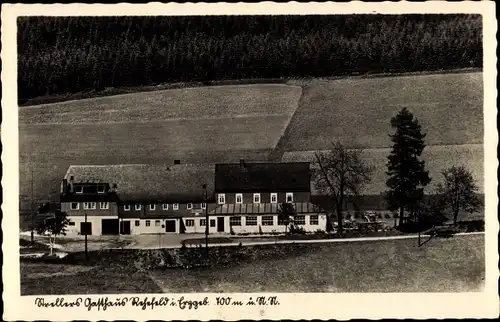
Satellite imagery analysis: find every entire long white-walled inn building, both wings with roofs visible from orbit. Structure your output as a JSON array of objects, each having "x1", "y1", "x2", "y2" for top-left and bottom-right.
[{"x1": 61, "y1": 160, "x2": 326, "y2": 235}]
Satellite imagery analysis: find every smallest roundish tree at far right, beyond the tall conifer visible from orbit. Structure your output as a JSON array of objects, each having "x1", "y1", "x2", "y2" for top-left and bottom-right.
[{"x1": 438, "y1": 166, "x2": 482, "y2": 225}]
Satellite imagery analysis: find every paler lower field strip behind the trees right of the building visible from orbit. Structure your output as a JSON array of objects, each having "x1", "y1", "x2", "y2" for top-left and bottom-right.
[{"x1": 283, "y1": 144, "x2": 484, "y2": 195}]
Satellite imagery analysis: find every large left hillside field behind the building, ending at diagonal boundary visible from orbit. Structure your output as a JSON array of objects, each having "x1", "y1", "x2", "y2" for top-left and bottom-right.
[{"x1": 19, "y1": 84, "x2": 301, "y2": 203}]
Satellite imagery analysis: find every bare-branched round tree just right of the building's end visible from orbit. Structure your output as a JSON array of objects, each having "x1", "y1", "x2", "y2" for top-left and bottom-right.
[{"x1": 312, "y1": 141, "x2": 373, "y2": 233}]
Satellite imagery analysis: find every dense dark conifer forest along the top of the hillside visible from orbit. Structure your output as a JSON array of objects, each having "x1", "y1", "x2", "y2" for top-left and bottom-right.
[{"x1": 17, "y1": 14, "x2": 482, "y2": 104}]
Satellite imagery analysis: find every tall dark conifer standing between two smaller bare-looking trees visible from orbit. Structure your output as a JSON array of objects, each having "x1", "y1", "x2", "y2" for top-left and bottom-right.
[{"x1": 385, "y1": 107, "x2": 431, "y2": 225}]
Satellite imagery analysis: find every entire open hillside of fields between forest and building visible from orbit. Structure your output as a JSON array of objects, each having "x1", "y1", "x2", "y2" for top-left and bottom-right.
[{"x1": 19, "y1": 73, "x2": 484, "y2": 209}]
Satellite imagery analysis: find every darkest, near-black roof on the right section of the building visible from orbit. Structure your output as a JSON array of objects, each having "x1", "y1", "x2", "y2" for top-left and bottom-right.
[{"x1": 215, "y1": 162, "x2": 311, "y2": 192}]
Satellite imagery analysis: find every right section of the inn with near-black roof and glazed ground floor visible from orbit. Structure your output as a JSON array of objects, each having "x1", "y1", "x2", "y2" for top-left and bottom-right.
[{"x1": 210, "y1": 160, "x2": 327, "y2": 234}]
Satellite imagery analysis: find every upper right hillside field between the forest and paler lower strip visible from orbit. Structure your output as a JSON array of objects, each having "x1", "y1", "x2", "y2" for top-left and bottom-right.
[{"x1": 281, "y1": 73, "x2": 483, "y2": 151}]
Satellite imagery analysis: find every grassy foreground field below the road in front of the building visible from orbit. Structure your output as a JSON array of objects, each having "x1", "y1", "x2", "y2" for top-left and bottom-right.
[{"x1": 21, "y1": 235, "x2": 484, "y2": 295}]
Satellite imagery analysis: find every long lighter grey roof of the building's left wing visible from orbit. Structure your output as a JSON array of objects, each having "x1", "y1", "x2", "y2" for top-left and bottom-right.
[{"x1": 64, "y1": 164, "x2": 214, "y2": 202}]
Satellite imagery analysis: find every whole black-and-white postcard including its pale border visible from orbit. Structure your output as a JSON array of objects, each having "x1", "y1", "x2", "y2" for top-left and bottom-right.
[{"x1": 2, "y1": 4, "x2": 498, "y2": 319}]
